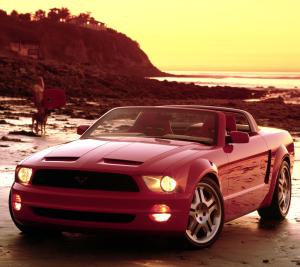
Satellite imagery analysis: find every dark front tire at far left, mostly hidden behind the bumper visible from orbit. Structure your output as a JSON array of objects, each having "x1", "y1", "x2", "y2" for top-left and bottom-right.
[{"x1": 8, "y1": 190, "x2": 61, "y2": 236}]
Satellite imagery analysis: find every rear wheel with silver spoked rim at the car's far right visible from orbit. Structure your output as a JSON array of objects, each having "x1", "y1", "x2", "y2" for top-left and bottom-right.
[{"x1": 257, "y1": 161, "x2": 292, "y2": 220}]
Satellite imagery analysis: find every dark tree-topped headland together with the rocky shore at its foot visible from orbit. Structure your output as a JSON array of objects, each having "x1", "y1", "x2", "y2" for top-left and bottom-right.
[{"x1": 0, "y1": 8, "x2": 263, "y2": 105}]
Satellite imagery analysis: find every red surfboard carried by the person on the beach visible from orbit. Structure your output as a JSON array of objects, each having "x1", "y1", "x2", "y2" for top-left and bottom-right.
[{"x1": 43, "y1": 89, "x2": 66, "y2": 110}]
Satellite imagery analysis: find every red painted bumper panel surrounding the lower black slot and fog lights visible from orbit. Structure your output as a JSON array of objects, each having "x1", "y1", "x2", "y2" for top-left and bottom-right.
[{"x1": 14, "y1": 184, "x2": 188, "y2": 233}]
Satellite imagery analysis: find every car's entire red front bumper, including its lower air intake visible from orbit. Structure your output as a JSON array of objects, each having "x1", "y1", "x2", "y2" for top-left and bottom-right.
[{"x1": 10, "y1": 183, "x2": 190, "y2": 233}]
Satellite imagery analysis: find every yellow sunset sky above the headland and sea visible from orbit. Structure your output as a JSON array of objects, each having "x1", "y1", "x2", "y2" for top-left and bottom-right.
[{"x1": 0, "y1": 0, "x2": 300, "y2": 71}]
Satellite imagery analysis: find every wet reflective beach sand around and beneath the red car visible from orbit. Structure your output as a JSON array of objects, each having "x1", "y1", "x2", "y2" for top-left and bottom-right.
[{"x1": 0, "y1": 99, "x2": 300, "y2": 267}]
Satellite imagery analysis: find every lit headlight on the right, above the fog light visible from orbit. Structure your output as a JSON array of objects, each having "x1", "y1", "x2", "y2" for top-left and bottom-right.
[{"x1": 143, "y1": 176, "x2": 177, "y2": 192}]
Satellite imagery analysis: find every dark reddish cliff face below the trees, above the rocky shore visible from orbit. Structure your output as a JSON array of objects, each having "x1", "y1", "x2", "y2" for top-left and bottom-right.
[{"x1": 0, "y1": 16, "x2": 161, "y2": 76}]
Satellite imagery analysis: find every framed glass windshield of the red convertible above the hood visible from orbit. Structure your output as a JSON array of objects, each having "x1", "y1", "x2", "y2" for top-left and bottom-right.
[{"x1": 82, "y1": 107, "x2": 217, "y2": 145}]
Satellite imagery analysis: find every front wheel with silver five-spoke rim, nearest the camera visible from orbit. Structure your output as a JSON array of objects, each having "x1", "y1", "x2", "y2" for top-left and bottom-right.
[{"x1": 185, "y1": 177, "x2": 224, "y2": 248}]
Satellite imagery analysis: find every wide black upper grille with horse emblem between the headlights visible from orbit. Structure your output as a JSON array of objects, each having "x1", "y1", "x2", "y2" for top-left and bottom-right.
[{"x1": 32, "y1": 169, "x2": 139, "y2": 192}]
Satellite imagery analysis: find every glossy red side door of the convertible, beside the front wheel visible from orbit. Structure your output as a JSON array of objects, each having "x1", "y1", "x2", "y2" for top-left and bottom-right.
[{"x1": 224, "y1": 114, "x2": 269, "y2": 219}]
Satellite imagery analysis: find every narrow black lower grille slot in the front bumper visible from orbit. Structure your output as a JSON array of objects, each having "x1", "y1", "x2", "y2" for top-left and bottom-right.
[{"x1": 32, "y1": 207, "x2": 135, "y2": 223}]
